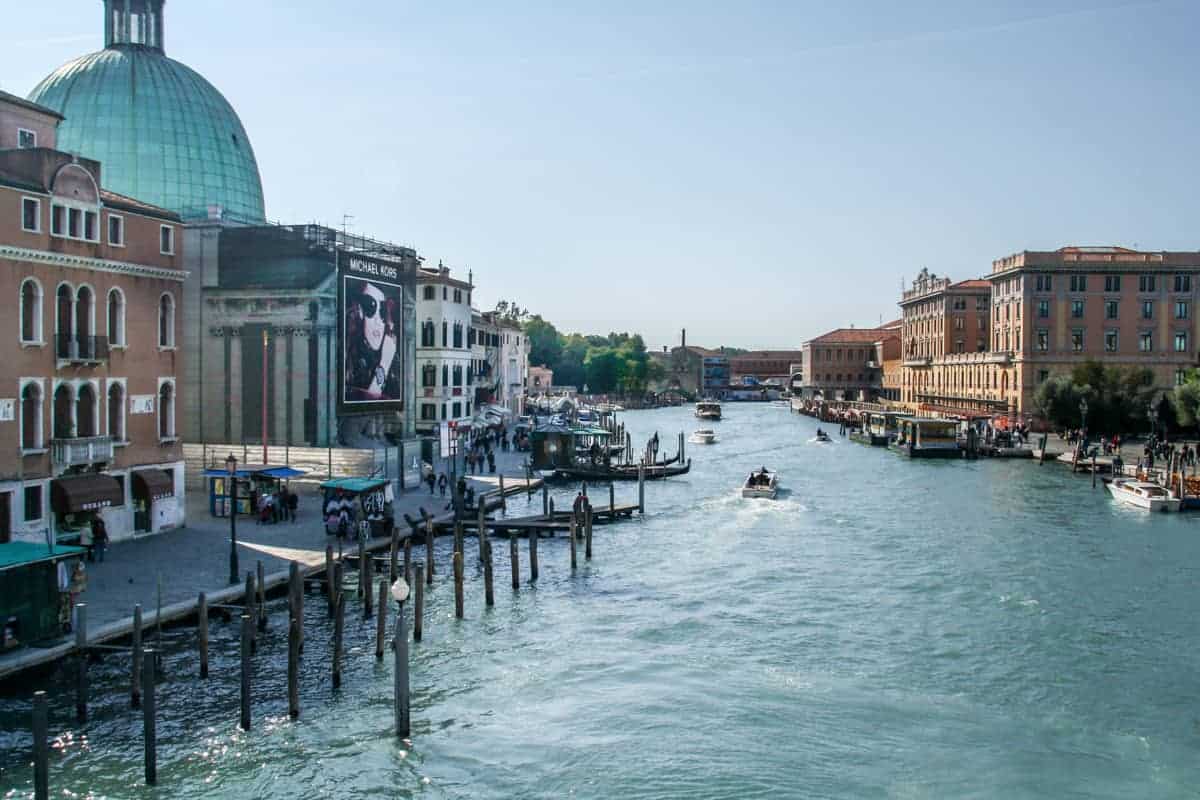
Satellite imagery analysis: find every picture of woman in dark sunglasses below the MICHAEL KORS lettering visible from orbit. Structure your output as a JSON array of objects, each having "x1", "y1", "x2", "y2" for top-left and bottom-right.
[{"x1": 342, "y1": 276, "x2": 404, "y2": 403}]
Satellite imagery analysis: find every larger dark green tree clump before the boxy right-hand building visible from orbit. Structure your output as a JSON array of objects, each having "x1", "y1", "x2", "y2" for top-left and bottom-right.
[{"x1": 1033, "y1": 361, "x2": 1156, "y2": 433}]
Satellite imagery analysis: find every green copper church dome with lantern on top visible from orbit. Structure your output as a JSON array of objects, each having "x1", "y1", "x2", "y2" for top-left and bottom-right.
[{"x1": 29, "y1": 0, "x2": 265, "y2": 222}]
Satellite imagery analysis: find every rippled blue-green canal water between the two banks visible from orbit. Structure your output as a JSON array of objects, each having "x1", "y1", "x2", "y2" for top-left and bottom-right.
[{"x1": 0, "y1": 404, "x2": 1200, "y2": 799}]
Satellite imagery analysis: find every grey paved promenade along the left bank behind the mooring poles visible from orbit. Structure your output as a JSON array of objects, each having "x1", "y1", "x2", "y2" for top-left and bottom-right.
[{"x1": 0, "y1": 452, "x2": 527, "y2": 678}]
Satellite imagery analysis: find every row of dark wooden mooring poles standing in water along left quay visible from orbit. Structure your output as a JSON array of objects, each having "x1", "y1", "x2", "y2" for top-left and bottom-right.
[{"x1": 25, "y1": 503, "x2": 609, "y2": 800}]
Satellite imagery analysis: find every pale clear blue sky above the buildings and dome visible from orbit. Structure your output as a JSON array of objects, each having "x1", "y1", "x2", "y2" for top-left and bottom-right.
[{"x1": 0, "y1": 0, "x2": 1200, "y2": 347}]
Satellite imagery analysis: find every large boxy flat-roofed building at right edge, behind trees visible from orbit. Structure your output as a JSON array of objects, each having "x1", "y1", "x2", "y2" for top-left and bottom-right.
[{"x1": 986, "y1": 247, "x2": 1200, "y2": 416}]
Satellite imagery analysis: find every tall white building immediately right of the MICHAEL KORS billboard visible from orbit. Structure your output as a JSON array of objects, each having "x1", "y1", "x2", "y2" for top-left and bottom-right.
[{"x1": 416, "y1": 261, "x2": 475, "y2": 434}]
